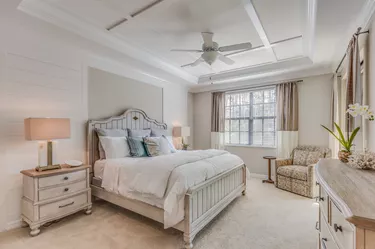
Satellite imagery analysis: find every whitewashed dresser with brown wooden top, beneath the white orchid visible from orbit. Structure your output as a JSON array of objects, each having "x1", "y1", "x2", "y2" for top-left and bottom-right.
[{"x1": 315, "y1": 159, "x2": 375, "y2": 249}]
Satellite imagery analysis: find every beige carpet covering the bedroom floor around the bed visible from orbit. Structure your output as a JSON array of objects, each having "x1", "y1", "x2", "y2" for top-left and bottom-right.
[{"x1": 0, "y1": 179, "x2": 318, "y2": 249}]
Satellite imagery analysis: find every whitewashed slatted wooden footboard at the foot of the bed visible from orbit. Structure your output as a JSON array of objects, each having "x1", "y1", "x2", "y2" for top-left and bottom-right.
[{"x1": 184, "y1": 164, "x2": 246, "y2": 249}]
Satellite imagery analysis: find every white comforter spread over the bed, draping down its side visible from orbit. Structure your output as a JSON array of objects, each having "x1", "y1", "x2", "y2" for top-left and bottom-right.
[{"x1": 102, "y1": 150, "x2": 243, "y2": 228}]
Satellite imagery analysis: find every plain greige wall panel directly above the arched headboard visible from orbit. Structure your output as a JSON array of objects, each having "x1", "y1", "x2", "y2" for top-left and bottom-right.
[{"x1": 88, "y1": 68, "x2": 163, "y2": 121}]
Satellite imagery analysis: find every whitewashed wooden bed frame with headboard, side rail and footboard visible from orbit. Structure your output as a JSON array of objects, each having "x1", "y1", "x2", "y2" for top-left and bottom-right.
[{"x1": 87, "y1": 109, "x2": 246, "y2": 249}]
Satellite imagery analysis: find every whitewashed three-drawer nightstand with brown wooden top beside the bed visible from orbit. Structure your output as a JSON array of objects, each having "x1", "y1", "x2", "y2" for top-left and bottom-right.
[{"x1": 21, "y1": 165, "x2": 92, "y2": 236}]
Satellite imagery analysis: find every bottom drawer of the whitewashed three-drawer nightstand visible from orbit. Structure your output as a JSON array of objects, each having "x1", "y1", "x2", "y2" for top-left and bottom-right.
[{"x1": 39, "y1": 192, "x2": 88, "y2": 219}]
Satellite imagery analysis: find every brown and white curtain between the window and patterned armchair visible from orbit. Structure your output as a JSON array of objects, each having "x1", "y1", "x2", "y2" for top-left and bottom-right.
[{"x1": 276, "y1": 82, "x2": 298, "y2": 158}]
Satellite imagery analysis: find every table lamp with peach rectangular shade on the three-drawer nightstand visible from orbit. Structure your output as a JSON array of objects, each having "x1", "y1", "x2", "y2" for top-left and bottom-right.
[{"x1": 24, "y1": 118, "x2": 70, "y2": 171}]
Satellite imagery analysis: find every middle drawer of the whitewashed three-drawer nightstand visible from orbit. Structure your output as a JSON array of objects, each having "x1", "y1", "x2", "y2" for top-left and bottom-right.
[{"x1": 39, "y1": 180, "x2": 87, "y2": 201}]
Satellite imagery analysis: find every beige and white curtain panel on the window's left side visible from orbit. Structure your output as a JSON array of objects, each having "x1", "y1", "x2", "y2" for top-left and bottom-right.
[{"x1": 211, "y1": 92, "x2": 225, "y2": 150}]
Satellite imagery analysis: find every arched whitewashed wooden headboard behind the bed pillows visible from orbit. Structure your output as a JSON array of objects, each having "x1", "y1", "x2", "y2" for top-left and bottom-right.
[{"x1": 87, "y1": 109, "x2": 167, "y2": 166}]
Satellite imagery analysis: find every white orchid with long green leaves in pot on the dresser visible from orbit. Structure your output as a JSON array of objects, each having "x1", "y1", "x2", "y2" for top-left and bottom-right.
[{"x1": 322, "y1": 103, "x2": 374, "y2": 163}]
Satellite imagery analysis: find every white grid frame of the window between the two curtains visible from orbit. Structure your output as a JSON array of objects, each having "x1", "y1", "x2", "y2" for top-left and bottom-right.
[{"x1": 224, "y1": 87, "x2": 277, "y2": 148}]
